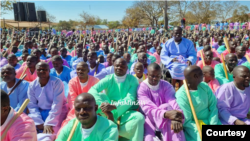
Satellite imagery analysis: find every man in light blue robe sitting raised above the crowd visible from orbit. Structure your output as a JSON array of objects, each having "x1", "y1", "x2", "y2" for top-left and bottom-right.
[{"x1": 160, "y1": 27, "x2": 197, "y2": 86}]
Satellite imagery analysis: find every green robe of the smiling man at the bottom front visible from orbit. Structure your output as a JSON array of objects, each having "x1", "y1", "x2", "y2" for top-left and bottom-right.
[{"x1": 56, "y1": 116, "x2": 118, "y2": 141}]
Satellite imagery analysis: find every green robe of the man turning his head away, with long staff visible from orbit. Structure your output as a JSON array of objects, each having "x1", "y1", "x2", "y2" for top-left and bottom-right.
[{"x1": 175, "y1": 82, "x2": 221, "y2": 141}]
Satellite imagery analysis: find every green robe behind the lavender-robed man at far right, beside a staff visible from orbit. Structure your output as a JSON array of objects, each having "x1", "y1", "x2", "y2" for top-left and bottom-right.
[{"x1": 214, "y1": 63, "x2": 234, "y2": 85}]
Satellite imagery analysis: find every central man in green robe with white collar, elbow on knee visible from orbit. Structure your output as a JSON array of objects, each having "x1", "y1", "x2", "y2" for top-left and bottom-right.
[{"x1": 89, "y1": 58, "x2": 145, "y2": 141}]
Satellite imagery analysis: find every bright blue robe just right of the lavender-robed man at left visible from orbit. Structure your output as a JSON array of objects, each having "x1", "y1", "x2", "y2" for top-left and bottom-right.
[{"x1": 50, "y1": 66, "x2": 71, "y2": 83}]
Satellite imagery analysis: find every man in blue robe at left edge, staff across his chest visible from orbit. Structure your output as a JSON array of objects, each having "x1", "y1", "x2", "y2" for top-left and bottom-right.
[{"x1": 0, "y1": 65, "x2": 29, "y2": 111}]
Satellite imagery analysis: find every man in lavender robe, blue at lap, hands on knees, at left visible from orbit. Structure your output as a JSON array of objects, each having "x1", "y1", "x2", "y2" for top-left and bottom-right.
[{"x1": 28, "y1": 62, "x2": 68, "y2": 140}]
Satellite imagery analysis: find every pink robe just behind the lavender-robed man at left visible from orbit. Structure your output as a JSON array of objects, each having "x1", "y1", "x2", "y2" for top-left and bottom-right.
[{"x1": 16, "y1": 65, "x2": 37, "y2": 83}]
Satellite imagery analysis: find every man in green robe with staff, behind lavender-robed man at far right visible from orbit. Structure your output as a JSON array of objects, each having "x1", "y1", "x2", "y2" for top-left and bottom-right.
[{"x1": 214, "y1": 53, "x2": 238, "y2": 85}]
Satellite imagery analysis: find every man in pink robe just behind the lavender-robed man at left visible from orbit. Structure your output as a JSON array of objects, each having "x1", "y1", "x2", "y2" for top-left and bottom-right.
[{"x1": 16, "y1": 56, "x2": 38, "y2": 82}]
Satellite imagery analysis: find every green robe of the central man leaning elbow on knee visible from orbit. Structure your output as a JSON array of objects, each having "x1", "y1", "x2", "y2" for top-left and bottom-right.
[{"x1": 88, "y1": 74, "x2": 145, "y2": 141}]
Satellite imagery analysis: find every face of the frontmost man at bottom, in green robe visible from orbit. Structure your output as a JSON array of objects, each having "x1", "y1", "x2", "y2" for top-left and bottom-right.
[{"x1": 74, "y1": 100, "x2": 98, "y2": 125}]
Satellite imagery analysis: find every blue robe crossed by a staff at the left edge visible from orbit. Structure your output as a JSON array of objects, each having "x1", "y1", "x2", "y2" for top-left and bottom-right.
[{"x1": 0, "y1": 78, "x2": 29, "y2": 111}]
